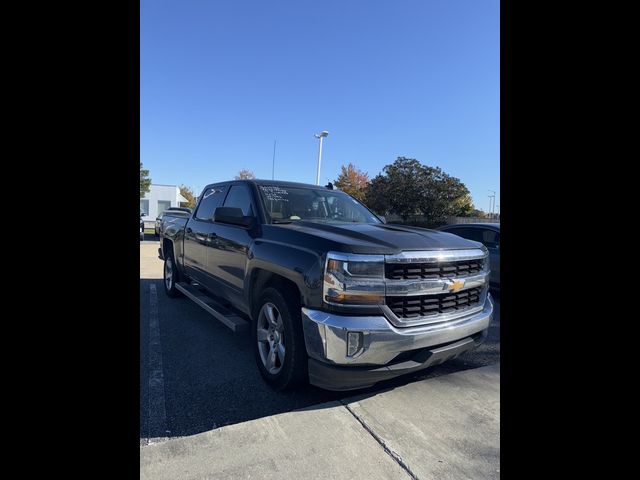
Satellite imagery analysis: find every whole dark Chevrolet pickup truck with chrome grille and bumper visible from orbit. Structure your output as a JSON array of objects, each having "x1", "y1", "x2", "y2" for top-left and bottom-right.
[{"x1": 159, "y1": 180, "x2": 493, "y2": 390}]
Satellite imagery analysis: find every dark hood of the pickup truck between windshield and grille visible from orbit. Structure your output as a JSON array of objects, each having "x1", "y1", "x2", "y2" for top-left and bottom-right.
[{"x1": 274, "y1": 220, "x2": 482, "y2": 255}]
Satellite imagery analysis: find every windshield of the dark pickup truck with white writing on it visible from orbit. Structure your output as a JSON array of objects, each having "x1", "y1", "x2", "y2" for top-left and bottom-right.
[{"x1": 259, "y1": 185, "x2": 382, "y2": 223}]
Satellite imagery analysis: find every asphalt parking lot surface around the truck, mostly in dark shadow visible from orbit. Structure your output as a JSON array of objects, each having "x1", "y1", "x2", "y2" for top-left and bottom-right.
[{"x1": 140, "y1": 235, "x2": 500, "y2": 445}]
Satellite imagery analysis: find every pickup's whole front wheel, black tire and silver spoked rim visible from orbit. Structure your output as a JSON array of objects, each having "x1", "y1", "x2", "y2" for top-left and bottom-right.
[{"x1": 251, "y1": 287, "x2": 307, "y2": 390}]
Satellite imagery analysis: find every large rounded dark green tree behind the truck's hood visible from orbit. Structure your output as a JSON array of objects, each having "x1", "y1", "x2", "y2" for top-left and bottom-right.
[{"x1": 366, "y1": 157, "x2": 473, "y2": 225}]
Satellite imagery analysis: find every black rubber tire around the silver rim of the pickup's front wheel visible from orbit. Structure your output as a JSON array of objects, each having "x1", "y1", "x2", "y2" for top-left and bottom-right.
[{"x1": 251, "y1": 287, "x2": 308, "y2": 390}]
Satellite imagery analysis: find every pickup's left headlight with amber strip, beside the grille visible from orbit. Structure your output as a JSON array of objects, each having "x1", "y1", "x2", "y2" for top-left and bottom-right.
[{"x1": 322, "y1": 252, "x2": 385, "y2": 305}]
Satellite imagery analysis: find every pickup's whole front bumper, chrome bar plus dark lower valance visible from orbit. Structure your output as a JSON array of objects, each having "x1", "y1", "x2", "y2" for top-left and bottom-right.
[{"x1": 302, "y1": 295, "x2": 493, "y2": 390}]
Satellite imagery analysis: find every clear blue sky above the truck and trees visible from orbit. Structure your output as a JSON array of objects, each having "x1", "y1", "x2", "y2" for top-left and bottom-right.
[{"x1": 140, "y1": 0, "x2": 500, "y2": 211}]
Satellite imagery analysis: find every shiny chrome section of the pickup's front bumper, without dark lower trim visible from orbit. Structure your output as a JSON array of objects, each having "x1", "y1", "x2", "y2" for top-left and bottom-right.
[{"x1": 302, "y1": 295, "x2": 493, "y2": 366}]
